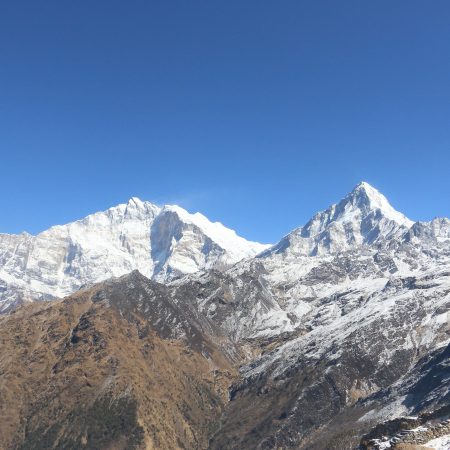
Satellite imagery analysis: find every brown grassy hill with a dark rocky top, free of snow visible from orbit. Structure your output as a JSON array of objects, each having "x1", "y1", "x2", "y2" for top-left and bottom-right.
[{"x1": 0, "y1": 272, "x2": 235, "y2": 450}]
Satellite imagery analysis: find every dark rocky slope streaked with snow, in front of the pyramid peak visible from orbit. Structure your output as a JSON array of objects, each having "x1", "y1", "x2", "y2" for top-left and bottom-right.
[{"x1": 209, "y1": 271, "x2": 450, "y2": 450}]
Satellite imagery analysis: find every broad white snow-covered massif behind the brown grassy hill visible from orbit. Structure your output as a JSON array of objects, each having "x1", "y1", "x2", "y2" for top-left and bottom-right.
[{"x1": 0, "y1": 198, "x2": 267, "y2": 311}]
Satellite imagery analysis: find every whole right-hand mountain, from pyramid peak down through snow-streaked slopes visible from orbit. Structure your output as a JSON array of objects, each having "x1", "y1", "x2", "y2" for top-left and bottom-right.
[{"x1": 199, "y1": 183, "x2": 450, "y2": 449}]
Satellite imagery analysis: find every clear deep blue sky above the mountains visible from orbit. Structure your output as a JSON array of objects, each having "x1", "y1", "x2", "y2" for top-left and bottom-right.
[{"x1": 0, "y1": 0, "x2": 450, "y2": 242}]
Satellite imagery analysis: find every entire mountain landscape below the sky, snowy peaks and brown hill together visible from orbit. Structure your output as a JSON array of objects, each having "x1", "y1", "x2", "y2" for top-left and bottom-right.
[{"x1": 0, "y1": 182, "x2": 450, "y2": 450}]
